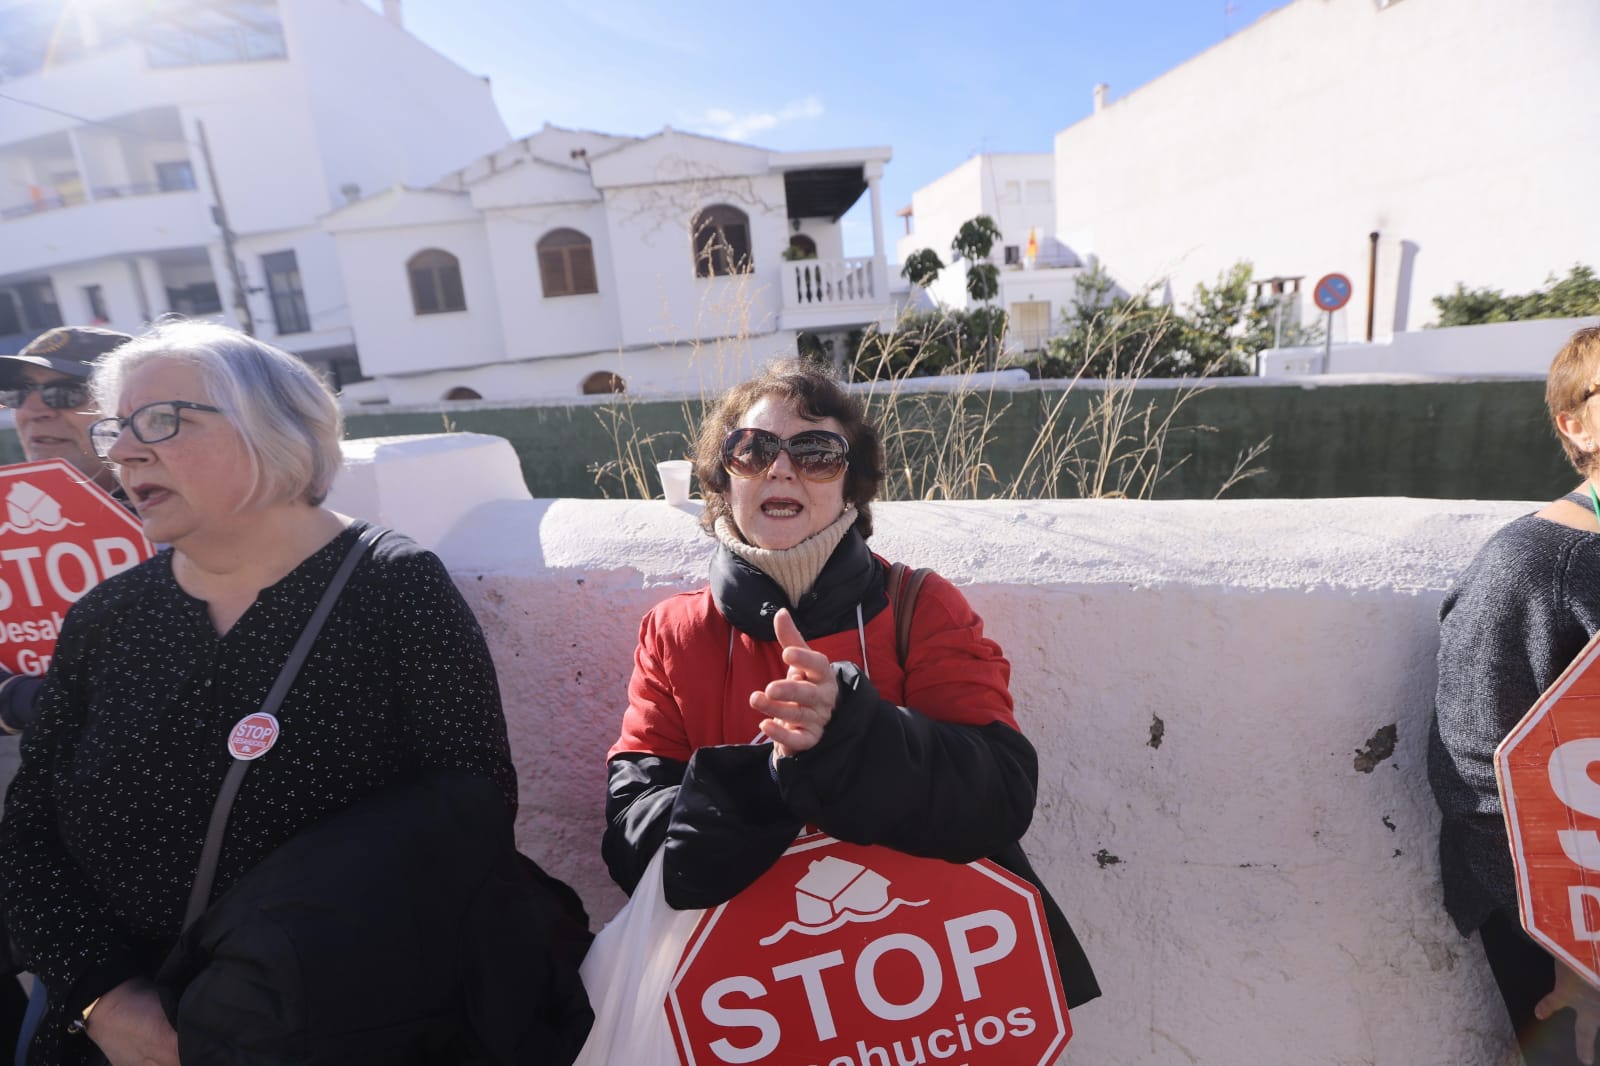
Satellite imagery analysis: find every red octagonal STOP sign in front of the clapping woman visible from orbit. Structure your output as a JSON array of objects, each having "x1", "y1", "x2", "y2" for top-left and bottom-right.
[{"x1": 666, "y1": 836, "x2": 1072, "y2": 1066}]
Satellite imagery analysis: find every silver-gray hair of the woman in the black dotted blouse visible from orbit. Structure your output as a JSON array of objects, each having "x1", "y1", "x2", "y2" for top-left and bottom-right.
[{"x1": 91, "y1": 320, "x2": 344, "y2": 506}]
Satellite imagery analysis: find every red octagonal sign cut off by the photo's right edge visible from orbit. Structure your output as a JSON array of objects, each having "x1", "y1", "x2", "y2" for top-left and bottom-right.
[{"x1": 1494, "y1": 635, "x2": 1600, "y2": 986}]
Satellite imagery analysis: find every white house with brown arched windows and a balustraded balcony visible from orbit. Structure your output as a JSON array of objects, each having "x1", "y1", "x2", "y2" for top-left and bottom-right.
[{"x1": 323, "y1": 125, "x2": 891, "y2": 403}]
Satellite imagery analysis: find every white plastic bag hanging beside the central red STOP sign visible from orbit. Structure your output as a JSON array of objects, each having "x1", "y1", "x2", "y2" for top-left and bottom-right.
[{"x1": 573, "y1": 848, "x2": 706, "y2": 1066}]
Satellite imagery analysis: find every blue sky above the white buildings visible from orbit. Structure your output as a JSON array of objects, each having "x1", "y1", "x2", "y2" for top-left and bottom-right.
[{"x1": 387, "y1": 0, "x2": 1310, "y2": 258}]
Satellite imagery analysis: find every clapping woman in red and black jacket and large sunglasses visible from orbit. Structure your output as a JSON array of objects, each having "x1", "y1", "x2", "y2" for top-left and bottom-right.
[{"x1": 603, "y1": 363, "x2": 1099, "y2": 1005}]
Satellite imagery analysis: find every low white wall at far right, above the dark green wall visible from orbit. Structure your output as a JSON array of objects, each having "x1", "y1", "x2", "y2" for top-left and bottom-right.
[{"x1": 1259, "y1": 319, "x2": 1600, "y2": 378}]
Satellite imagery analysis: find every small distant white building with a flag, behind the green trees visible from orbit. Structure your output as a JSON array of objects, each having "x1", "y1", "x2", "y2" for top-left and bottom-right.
[{"x1": 896, "y1": 152, "x2": 1080, "y2": 351}]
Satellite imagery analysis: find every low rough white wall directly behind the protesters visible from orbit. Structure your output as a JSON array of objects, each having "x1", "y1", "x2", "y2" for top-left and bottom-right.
[{"x1": 324, "y1": 437, "x2": 1531, "y2": 1066}]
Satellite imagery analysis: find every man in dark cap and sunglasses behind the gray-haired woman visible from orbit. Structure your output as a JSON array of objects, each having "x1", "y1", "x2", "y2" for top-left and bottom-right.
[{"x1": 0, "y1": 327, "x2": 133, "y2": 736}]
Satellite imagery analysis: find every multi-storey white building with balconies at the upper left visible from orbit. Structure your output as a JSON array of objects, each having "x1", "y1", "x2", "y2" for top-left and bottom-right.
[{"x1": 0, "y1": 0, "x2": 507, "y2": 376}]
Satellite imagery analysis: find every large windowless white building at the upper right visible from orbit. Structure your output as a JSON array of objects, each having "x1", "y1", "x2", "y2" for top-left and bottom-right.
[{"x1": 1054, "y1": 0, "x2": 1600, "y2": 341}]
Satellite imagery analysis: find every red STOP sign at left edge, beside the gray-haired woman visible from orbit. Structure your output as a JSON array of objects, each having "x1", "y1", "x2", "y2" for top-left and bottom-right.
[{"x1": 0, "y1": 459, "x2": 154, "y2": 674}]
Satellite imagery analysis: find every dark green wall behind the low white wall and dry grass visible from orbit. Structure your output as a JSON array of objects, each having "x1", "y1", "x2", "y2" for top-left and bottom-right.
[{"x1": 0, "y1": 381, "x2": 1576, "y2": 499}]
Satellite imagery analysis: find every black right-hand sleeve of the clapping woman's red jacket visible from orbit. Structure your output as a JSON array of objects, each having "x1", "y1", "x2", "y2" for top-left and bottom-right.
[{"x1": 778, "y1": 663, "x2": 1038, "y2": 863}]
